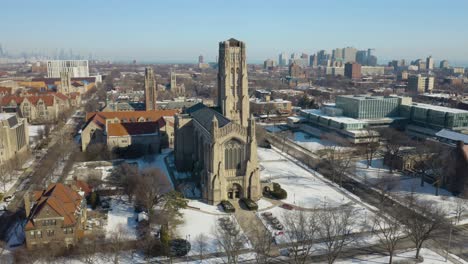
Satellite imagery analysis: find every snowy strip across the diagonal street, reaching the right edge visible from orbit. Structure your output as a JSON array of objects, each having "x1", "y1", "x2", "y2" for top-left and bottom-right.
[{"x1": 355, "y1": 158, "x2": 468, "y2": 221}]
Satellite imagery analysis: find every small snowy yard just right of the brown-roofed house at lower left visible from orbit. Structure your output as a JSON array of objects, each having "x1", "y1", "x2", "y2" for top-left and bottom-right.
[{"x1": 106, "y1": 196, "x2": 138, "y2": 239}]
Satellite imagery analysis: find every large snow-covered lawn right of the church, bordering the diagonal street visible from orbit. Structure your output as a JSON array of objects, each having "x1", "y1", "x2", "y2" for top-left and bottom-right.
[{"x1": 257, "y1": 148, "x2": 373, "y2": 244}]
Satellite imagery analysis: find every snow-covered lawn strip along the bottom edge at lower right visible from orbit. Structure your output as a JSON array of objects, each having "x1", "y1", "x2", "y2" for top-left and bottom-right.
[{"x1": 336, "y1": 248, "x2": 462, "y2": 264}]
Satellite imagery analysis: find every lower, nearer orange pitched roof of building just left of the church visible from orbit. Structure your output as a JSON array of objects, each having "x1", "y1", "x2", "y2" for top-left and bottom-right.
[{"x1": 107, "y1": 118, "x2": 164, "y2": 137}]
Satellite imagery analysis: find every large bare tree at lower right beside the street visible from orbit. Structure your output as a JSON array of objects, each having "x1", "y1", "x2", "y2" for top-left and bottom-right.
[{"x1": 399, "y1": 201, "x2": 446, "y2": 258}]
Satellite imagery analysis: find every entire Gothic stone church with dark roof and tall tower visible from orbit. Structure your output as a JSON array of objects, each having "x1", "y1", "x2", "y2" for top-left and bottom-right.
[{"x1": 174, "y1": 39, "x2": 261, "y2": 204}]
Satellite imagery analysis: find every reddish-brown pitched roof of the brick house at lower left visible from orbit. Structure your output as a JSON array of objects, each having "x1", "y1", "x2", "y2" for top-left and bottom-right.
[{"x1": 25, "y1": 183, "x2": 83, "y2": 230}]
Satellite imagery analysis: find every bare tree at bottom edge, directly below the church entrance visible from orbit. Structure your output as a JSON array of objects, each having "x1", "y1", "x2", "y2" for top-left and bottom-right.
[{"x1": 214, "y1": 220, "x2": 246, "y2": 264}]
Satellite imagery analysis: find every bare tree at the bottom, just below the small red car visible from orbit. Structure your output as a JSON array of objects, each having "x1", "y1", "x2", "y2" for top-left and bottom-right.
[{"x1": 283, "y1": 211, "x2": 318, "y2": 264}]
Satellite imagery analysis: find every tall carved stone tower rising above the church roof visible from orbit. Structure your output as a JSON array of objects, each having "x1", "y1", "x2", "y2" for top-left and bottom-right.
[{"x1": 218, "y1": 38, "x2": 250, "y2": 127}]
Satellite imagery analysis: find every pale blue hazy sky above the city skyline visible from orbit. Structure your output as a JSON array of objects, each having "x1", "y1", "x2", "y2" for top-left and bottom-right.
[{"x1": 0, "y1": 0, "x2": 468, "y2": 62}]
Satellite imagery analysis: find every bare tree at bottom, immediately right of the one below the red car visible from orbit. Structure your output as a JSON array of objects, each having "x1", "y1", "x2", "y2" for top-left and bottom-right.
[{"x1": 318, "y1": 208, "x2": 353, "y2": 264}]
